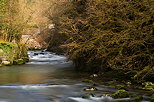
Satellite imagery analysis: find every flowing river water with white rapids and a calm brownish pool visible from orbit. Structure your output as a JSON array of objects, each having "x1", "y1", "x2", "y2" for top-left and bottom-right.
[{"x1": 0, "y1": 50, "x2": 150, "y2": 102}]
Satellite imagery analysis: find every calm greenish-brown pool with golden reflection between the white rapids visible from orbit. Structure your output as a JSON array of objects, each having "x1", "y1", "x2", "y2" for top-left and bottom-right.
[{"x1": 0, "y1": 65, "x2": 75, "y2": 85}]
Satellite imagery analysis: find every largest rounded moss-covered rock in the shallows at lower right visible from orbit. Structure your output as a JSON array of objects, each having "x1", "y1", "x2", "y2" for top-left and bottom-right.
[{"x1": 112, "y1": 90, "x2": 129, "y2": 98}]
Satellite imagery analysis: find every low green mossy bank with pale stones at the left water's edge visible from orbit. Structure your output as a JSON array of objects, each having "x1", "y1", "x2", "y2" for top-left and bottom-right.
[{"x1": 0, "y1": 42, "x2": 28, "y2": 66}]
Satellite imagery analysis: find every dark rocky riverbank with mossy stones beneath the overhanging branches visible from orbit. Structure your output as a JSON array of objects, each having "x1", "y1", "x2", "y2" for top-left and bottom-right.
[{"x1": 80, "y1": 71, "x2": 154, "y2": 102}]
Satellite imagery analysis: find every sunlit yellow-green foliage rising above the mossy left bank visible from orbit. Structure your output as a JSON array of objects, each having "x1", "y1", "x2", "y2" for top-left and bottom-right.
[{"x1": 0, "y1": 0, "x2": 24, "y2": 43}]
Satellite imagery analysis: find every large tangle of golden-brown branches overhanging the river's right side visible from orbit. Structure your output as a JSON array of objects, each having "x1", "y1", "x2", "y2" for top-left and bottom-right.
[{"x1": 47, "y1": 0, "x2": 154, "y2": 79}]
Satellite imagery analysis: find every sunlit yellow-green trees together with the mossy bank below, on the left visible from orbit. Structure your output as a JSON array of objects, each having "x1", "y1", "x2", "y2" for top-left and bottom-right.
[{"x1": 0, "y1": 0, "x2": 28, "y2": 66}]
